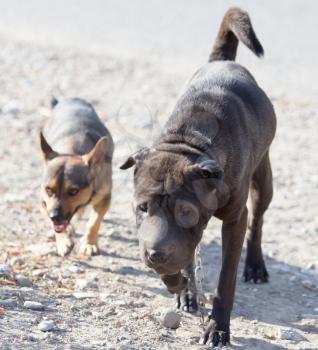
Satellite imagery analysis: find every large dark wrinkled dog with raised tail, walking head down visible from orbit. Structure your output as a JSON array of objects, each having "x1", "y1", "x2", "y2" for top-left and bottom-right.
[{"x1": 121, "y1": 8, "x2": 276, "y2": 346}]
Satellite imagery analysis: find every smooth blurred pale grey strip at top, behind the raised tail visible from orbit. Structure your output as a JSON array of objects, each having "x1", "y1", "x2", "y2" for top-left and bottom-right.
[{"x1": 0, "y1": 0, "x2": 318, "y2": 97}]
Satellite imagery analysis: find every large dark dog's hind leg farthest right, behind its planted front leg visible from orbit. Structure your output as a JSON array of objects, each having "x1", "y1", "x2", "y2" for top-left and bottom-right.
[{"x1": 243, "y1": 153, "x2": 273, "y2": 283}]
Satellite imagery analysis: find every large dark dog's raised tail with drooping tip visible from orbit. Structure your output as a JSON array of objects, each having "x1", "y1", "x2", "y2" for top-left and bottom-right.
[{"x1": 209, "y1": 7, "x2": 264, "y2": 62}]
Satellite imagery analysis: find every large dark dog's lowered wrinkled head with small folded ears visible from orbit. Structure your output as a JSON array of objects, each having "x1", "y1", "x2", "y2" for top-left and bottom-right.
[{"x1": 121, "y1": 150, "x2": 223, "y2": 275}]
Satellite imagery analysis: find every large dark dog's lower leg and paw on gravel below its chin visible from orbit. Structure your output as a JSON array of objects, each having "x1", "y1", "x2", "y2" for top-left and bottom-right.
[{"x1": 176, "y1": 263, "x2": 198, "y2": 312}]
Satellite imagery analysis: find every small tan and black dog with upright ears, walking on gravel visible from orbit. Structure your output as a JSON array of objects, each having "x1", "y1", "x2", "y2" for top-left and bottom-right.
[{"x1": 40, "y1": 98, "x2": 114, "y2": 256}]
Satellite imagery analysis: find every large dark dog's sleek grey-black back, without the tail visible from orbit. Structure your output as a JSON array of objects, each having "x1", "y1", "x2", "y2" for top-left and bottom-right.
[{"x1": 166, "y1": 61, "x2": 276, "y2": 177}]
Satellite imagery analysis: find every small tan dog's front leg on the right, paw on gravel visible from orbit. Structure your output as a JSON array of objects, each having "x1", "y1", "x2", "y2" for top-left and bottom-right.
[{"x1": 80, "y1": 195, "x2": 110, "y2": 255}]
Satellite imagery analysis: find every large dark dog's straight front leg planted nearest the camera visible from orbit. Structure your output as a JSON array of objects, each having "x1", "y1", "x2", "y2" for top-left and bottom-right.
[{"x1": 201, "y1": 208, "x2": 247, "y2": 346}]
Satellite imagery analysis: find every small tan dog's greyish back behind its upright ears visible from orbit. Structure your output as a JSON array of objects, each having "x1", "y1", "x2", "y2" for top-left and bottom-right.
[{"x1": 44, "y1": 98, "x2": 113, "y2": 156}]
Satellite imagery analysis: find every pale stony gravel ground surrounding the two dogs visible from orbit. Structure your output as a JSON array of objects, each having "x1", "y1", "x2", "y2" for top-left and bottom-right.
[{"x1": 0, "y1": 32, "x2": 318, "y2": 350}]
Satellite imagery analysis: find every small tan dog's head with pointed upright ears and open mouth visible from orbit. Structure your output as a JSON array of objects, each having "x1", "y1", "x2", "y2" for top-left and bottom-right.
[{"x1": 40, "y1": 133, "x2": 107, "y2": 232}]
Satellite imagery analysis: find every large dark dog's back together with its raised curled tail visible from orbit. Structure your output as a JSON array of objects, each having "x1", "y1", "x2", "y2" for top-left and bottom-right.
[{"x1": 165, "y1": 8, "x2": 276, "y2": 182}]
